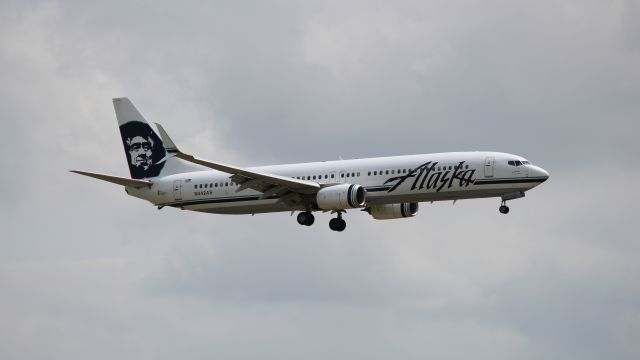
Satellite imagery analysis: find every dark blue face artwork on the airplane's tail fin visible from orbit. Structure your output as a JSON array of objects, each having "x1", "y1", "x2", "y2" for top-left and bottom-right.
[{"x1": 120, "y1": 121, "x2": 166, "y2": 179}]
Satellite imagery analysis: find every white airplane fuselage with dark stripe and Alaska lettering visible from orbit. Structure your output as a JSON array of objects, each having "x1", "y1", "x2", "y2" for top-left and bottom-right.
[{"x1": 127, "y1": 151, "x2": 549, "y2": 214}]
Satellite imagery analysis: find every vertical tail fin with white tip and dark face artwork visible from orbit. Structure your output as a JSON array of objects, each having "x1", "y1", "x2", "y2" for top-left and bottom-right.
[{"x1": 113, "y1": 98, "x2": 167, "y2": 179}]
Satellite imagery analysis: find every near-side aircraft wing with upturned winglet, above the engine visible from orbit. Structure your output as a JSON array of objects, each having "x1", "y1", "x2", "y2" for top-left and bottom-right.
[{"x1": 156, "y1": 123, "x2": 320, "y2": 197}]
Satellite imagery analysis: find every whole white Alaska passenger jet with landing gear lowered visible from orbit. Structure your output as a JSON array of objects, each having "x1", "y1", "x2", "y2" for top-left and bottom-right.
[{"x1": 71, "y1": 98, "x2": 549, "y2": 232}]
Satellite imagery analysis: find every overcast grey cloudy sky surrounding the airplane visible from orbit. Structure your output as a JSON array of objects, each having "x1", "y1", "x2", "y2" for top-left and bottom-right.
[{"x1": 0, "y1": 0, "x2": 640, "y2": 359}]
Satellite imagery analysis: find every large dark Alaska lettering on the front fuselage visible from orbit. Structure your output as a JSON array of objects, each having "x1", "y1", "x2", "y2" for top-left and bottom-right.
[{"x1": 385, "y1": 161, "x2": 476, "y2": 192}]
